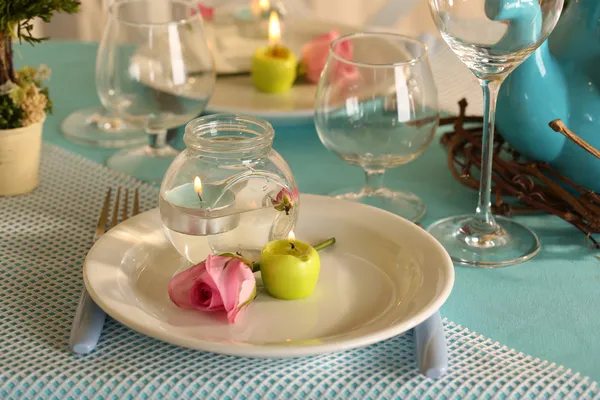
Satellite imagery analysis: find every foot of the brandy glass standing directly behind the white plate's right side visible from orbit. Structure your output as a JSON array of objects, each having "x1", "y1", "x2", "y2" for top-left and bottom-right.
[{"x1": 329, "y1": 187, "x2": 427, "y2": 222}]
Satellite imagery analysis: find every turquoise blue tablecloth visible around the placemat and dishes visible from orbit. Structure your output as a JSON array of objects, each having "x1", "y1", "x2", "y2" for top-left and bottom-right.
[{"x1": 15, "y1": 42, "x2": 600, "y2": 380}]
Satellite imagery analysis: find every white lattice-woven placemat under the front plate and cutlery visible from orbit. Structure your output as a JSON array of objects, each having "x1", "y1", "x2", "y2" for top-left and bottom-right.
[{"x1": 0, "y1": 145, "x2": 600, "y2": 400}]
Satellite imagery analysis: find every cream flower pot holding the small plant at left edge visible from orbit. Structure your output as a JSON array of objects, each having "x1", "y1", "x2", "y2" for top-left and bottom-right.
[{"x1": 0, "y1": 116, "x2": 44, "y2": 196}]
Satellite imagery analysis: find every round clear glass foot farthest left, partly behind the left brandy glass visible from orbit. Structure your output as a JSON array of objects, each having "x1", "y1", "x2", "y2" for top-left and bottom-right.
[{"x1": 61, "y1": 107, "x2": 148, "y2": 148}]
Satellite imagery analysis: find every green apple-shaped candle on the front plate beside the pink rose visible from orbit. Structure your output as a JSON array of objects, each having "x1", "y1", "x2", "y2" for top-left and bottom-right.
[{"x1": 260, "y1": 239, "x2": 321, "y2": 300}]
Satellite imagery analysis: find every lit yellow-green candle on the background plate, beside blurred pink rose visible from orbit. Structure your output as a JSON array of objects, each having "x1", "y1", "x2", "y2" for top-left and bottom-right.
[{"x1": 250, "y1": 11, "x2": 297, "y2": 93}]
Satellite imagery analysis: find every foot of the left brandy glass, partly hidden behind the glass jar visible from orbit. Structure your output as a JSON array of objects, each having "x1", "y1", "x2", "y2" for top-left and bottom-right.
[{"x1": 106, "y1": 146, "x2": 179, "y2": 183}]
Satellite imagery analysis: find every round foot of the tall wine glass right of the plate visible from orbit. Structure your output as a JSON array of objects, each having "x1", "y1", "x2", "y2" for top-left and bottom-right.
[{"x1": 427, "y1": 215, "x2": 540, "y2": 268}]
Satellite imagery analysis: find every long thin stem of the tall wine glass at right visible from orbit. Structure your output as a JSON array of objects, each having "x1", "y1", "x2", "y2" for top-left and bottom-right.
[{"x1": 475, "y1": 79, "x2": 502, "y2": 231}]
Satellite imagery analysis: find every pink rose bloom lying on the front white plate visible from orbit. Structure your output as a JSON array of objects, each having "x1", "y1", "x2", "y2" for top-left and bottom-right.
[{"x1": 169, "y1": 255, "x2": 256, "y2": 324}]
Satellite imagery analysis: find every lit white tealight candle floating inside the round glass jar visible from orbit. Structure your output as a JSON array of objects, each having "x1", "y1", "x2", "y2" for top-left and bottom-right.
[{"x1": 160, "y1": 176, "x2": 239, "y2": 236}]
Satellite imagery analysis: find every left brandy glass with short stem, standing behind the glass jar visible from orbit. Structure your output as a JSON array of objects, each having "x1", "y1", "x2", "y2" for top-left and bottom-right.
[{"x1": 96, "y1": 0, "x2": 215, "y2": 182}]
